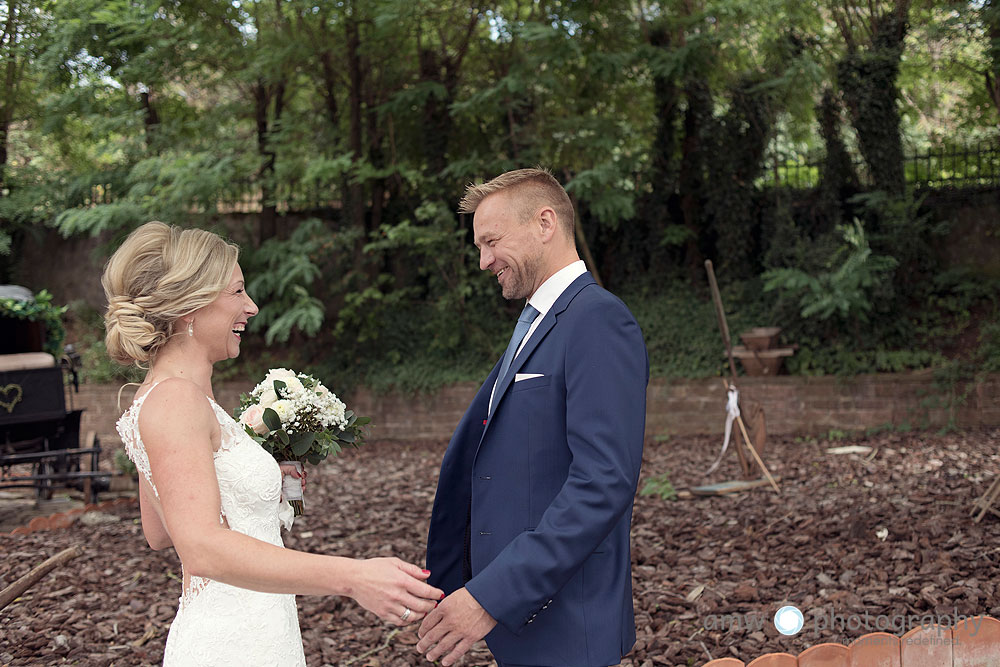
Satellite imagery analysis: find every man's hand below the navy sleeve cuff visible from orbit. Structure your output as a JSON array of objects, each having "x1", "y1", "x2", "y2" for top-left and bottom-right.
[{"x1": 417, "y1": 588, "x2": 497, "y2": 667}]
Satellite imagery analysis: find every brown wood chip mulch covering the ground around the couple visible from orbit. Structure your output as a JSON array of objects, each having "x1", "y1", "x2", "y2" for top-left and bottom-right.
[{"x1": 0, "y1": 429, "x2": 1000, "y2": 667}]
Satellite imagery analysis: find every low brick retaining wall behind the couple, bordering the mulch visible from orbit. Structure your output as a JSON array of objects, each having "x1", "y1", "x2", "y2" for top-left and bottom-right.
[{"x1": 72, "y1": 373, "x2": 1000, "y2": 450}]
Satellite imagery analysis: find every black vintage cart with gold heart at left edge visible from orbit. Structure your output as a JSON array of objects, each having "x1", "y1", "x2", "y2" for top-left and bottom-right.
[{"x1": 0, "y1": 290, "x2": 110, "y2": 502}]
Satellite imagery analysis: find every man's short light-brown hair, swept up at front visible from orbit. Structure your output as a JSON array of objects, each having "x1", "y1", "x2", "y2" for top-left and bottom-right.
[{"x1": 458, "y1": 167, "x2": 574, "y2": 238}]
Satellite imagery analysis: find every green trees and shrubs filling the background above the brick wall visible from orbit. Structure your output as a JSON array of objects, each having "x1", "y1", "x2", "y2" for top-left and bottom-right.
[{"x1": 0, "y1": 0, "x2": 1000, "y2": 391}]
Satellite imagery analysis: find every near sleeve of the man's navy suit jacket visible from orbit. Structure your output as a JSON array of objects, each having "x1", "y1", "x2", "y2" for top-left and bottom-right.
[{"x1": 466, "y1": 295, "x2": 649, "y2": 634}]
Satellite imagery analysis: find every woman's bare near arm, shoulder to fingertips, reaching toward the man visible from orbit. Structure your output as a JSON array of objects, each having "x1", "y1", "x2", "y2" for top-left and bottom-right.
[{"x1": 139, "y1": 380, "x2": 442, "y2": 622}]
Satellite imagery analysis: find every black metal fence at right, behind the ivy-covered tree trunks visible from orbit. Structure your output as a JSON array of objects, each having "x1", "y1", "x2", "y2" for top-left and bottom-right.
[{"x1": 757, "y1": 142, "x2": 1000, "y2": 189}]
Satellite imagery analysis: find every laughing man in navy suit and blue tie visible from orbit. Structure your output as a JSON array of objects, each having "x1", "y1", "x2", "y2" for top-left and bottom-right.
[{"x1": 417, "y1": 169, "x2": 649, "y2": 667}]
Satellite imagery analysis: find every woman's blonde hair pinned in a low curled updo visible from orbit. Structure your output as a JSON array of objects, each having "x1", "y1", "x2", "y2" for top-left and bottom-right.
[{"x1": 101, "y1": 222, "x2": 239, "y2": 366}]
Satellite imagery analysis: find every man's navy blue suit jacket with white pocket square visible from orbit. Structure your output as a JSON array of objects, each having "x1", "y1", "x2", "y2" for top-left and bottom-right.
[{"x1": 427, "y1": 273, "x2": 649, "y2": 667}]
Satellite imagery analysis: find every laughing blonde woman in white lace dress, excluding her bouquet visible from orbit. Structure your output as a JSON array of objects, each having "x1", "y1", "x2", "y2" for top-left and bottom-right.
[{"x1": 101, "y1": 222, "x2": 444, "y2": 667}]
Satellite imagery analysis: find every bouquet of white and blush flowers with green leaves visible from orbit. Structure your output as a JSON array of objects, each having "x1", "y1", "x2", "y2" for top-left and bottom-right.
[{"x1": 235, "y1": 368, "x2": 371, "y2": 516}]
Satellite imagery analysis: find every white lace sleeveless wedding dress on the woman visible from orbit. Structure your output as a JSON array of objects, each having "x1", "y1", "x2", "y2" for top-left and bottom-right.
[{"x1": 117, "y1": 384, "x2": 306, "y2": 667}]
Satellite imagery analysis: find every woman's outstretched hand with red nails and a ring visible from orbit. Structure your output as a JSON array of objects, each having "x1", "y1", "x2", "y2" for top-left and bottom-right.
[{"x1": 350, "y1": 558, "x2": 444, "y2": 625}]
